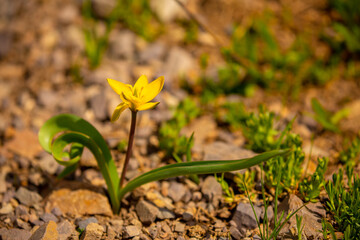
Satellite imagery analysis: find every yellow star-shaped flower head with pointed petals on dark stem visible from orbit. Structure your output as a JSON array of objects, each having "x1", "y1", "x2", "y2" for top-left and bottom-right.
[{"x1": 107, "y1": 75, "x2": 164, "y2": 122}]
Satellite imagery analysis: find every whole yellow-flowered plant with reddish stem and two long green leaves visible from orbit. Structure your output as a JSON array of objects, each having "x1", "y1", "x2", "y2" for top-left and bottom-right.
[{"x1": 39, "y1": 76, "x2": 290, "y2": 214}]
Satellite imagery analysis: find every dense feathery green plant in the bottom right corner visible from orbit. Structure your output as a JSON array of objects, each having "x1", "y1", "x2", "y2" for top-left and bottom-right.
[{"x1": 325, "y1": 169, "x2": 360, "y2": 240}]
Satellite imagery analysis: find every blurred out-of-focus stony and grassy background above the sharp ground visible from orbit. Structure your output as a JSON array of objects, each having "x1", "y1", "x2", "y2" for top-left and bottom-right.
[{"x1": 0, "y1": 0, "x2": 360, "y2": 133}]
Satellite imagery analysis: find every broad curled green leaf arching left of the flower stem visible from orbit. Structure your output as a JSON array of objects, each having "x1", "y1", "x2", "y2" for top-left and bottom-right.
[{"x1": 39, "y1": 114, "x2": 120, "y2": 212}]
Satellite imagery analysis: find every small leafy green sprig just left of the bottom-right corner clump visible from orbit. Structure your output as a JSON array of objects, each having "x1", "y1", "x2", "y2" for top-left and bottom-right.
[{"x1": 299, "y1": 158, "x2": 329, "y2": 202}]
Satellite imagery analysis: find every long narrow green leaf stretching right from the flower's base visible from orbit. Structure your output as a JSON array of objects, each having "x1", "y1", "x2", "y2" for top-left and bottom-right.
[{"x1": 119, "y1": 149, "x2": 290, "y2": 202}]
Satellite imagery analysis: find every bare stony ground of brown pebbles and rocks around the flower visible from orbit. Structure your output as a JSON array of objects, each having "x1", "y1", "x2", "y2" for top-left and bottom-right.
[{"x1": 0, "y1": 0, "x2": 360, "y2": 240}]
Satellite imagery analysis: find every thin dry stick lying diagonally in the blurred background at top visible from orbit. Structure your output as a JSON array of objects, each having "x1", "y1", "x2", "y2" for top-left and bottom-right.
[{"x1": 175, "y1": 0, "x2": 251, "y2": 68}]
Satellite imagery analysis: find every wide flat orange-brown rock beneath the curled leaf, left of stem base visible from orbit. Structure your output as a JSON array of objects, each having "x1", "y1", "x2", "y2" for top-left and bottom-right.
[{"x1": 45, "y1": 188, "x2": 112, "y2": 216}]
